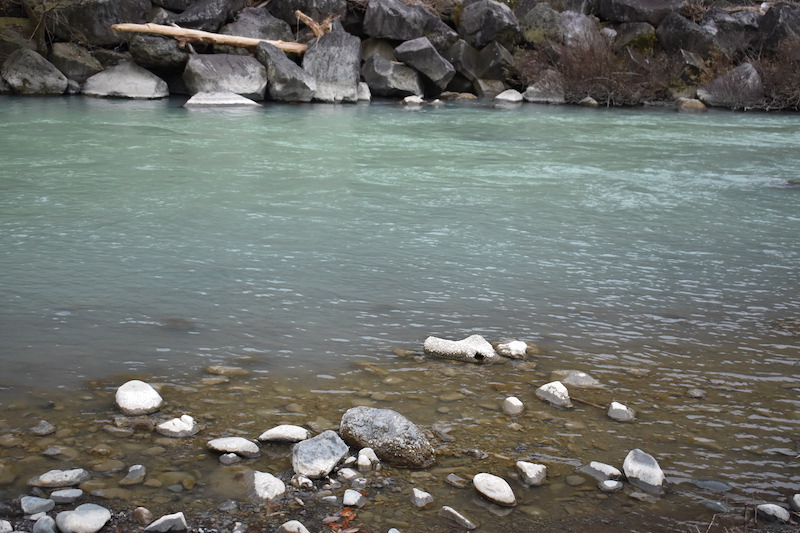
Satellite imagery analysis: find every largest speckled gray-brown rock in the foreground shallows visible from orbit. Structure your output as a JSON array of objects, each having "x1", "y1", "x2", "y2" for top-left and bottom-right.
[{"x1": 339, "y1": 406, "x2": 436, "y2": 468}]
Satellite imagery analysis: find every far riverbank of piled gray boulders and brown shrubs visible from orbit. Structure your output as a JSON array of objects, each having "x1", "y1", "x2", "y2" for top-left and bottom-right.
[{"x1": 0, "y1": 0, "x2": 800, "y2": 111}]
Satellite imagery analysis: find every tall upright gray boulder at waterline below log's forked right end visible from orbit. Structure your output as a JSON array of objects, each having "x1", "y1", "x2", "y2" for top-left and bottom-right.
[{"x1": 303, "y1": 31, "x2": 361, "y2": 103}]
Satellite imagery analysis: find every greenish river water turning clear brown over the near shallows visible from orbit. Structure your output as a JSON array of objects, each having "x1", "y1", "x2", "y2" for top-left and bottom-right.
[{"x1": 0, "y1": 98, "x2": 800, "y2": 531}]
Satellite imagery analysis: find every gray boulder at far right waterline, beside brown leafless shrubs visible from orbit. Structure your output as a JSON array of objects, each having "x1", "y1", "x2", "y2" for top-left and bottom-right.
[{"x1": 697, "y1": 63, "x2": 764, "y2": 109}]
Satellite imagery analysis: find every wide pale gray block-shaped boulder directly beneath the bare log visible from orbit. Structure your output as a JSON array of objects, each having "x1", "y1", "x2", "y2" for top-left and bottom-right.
[{"x1": 183, "y1": 54, "x2": 267, "y2": 100}]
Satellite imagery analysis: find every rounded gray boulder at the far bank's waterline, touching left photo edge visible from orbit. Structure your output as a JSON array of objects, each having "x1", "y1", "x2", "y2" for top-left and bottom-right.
[{"x1": 0, "y1": 48, "x2": 68, "y2": 95}]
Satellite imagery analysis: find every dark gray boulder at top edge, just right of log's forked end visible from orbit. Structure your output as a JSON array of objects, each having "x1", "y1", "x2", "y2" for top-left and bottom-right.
[{"x1": 364, "y1": 0, "x2": 458, "y2": 51}]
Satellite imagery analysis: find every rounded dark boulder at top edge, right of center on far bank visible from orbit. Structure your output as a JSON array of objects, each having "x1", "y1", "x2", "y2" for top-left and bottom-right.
[{"x1": 457, "y1": 0, "x2": 520, "y2": 48}]
